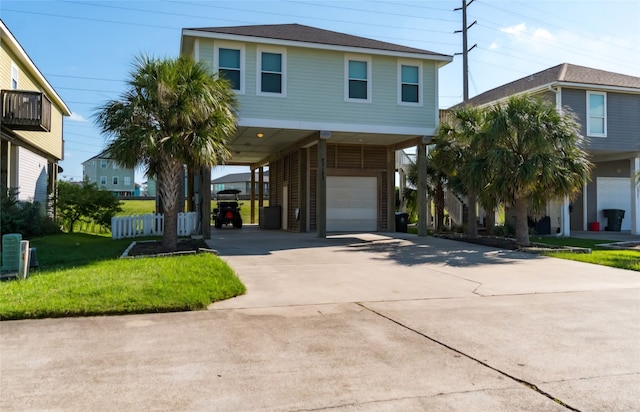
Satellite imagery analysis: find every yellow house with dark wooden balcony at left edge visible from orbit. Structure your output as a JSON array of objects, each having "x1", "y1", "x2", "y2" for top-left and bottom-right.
[{"x1": 0, "y1": 20, "x2": 71, "y2": 212}]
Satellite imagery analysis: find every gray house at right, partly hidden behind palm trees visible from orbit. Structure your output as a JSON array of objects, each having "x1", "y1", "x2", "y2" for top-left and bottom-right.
[{"x1": 458, "y1": 63, "x2": 640, "y2": 236}]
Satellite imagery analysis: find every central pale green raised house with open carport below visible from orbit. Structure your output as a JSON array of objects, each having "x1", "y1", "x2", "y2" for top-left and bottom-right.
[{"x1": 181, "y1": 24, "x2": 452, "y2": 232}]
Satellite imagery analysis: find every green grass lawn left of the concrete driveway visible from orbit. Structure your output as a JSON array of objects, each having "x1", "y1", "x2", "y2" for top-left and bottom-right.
[{"x1": 0, "y1": 234, "x2": 246, "y2": 320}]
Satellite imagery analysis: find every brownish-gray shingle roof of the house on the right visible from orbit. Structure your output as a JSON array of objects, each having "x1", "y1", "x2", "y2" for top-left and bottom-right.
[{"x1": 454, "y1": 63, "x2": 640, "y2": 107}]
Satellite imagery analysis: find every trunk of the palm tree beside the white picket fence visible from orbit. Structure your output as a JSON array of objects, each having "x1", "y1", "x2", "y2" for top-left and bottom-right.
[{"x1": 158, "y1": 158, "x2": 183, "y2": 250}]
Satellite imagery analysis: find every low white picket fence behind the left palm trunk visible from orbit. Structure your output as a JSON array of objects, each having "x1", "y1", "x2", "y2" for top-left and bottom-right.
[{"x1": 111, "y1": 212, "x2": 198, "y2": 239}]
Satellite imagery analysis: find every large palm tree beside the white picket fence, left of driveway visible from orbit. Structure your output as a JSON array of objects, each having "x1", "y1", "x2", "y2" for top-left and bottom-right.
[{"x1": 96, "y1": 56, "x2": 236, "y2": 250}]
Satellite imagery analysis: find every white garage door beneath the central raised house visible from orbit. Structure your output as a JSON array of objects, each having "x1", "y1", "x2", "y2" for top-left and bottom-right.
[{"x1": 327, "y1": 176, "x2": 378, "y2": 232}]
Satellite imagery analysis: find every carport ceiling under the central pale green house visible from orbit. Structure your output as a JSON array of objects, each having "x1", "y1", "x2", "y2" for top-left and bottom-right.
[{"x1": 227, "y1": 127, "x2": 415, "y2": 165}]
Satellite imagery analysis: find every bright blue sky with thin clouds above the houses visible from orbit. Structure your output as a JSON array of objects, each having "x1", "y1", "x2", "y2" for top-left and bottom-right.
[{"x1": 0, "y1": 0, "x2": 640, "y2": 183}]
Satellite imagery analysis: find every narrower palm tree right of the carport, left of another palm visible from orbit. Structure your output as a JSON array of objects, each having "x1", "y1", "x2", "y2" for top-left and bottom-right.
[{"x1": 434, "y1": 106, "x2": 486, "y2": 237}]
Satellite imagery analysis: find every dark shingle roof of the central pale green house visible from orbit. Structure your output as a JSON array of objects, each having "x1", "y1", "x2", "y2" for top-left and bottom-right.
[{"x1": 185, "y1": 24, "x2": 451, "y2": 57}]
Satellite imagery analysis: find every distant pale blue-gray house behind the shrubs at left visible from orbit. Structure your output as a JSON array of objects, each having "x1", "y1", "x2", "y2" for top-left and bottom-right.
[{"x1": 82, "y1": 152, "x2": 136, "y2": 196}]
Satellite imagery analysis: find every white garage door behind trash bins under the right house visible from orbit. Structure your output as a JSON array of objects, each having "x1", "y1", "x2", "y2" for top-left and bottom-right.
[{"x1": 596, "y1": 177, "x2": 631, "y2": 230}]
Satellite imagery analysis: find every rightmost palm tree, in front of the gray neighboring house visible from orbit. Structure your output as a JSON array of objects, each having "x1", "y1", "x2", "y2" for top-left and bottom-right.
[{"x1": 485, "y1": 96, "x2": 592, "y2": 246}]
